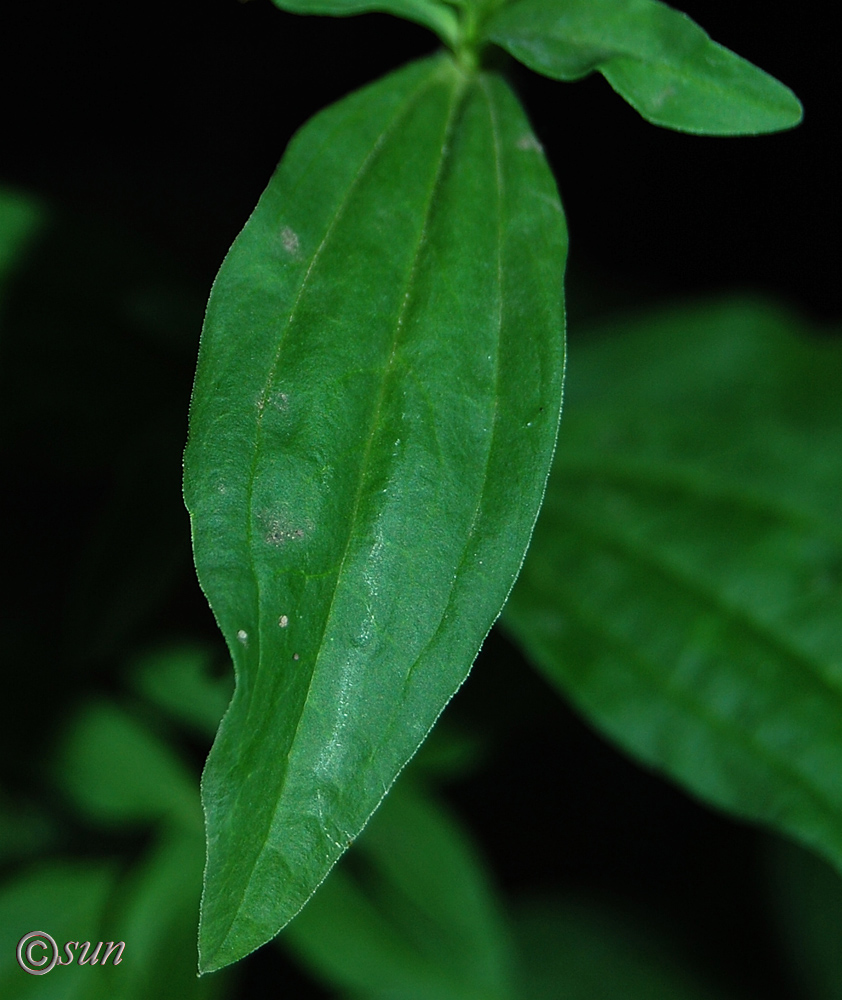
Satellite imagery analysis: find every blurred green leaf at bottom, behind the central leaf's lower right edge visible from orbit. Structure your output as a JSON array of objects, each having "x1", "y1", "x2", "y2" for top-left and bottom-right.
[{"x1": 279, "y1": 780, "x2": 509, "y2": 1000}]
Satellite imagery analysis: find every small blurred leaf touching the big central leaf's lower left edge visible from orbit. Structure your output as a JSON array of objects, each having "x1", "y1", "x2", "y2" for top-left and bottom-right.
[{"x1": 129, "y1": 645, "x2": 234, "y2": 736}]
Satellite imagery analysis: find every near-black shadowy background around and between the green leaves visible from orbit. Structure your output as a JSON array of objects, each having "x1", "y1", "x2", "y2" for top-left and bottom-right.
[{"x1": 0, "y1": 0, "x2": 842, "y2": 1000}]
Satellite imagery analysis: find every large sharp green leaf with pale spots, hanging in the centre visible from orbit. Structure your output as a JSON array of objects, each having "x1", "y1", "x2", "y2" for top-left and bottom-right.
[{"x1": 185, "y1": 50, "x2": 566, "y2": 971}]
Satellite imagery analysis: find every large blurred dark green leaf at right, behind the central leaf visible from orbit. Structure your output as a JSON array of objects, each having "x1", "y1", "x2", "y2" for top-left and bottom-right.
[{"x1": 504, "y1": 301, "x2": 842, "y2": 866}]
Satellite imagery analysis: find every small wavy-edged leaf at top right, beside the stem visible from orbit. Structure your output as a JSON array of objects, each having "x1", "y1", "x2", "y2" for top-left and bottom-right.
[{"x1": 486, "y1": 0, "x2": 802, "y2": 135}]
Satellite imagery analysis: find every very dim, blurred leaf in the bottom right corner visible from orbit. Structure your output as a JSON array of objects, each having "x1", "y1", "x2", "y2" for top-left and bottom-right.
[{"x1": 767, "y1": 838, "x2": 842, "y2": 1000}]
